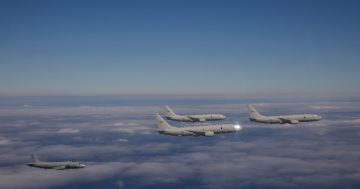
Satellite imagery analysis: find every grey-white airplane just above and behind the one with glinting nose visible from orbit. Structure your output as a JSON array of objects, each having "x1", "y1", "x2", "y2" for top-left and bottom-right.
[{"x1": 165, "y1": 105, "x2": 226, "y2": 122}]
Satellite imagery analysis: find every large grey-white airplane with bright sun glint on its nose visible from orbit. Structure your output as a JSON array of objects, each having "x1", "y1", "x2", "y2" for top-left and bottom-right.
[{"x1": 155, "y1": 114, "x2": 242, "y2": 137}]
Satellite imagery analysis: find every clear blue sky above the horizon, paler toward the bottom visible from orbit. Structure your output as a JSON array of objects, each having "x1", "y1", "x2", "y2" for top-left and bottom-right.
[{"x1": 0, "y1": 0, "x2": 360, "y2": 96}]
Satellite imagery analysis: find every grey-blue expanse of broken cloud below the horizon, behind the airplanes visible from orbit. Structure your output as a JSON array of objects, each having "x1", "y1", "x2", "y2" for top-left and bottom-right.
[{"x1": 0, "y1": 97, "x2": 360, "y2": 189}]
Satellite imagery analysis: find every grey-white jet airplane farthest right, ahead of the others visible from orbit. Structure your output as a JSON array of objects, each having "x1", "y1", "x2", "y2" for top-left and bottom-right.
[{"x1": 247, "y1": 105, "x2": 322, "y2": 124}]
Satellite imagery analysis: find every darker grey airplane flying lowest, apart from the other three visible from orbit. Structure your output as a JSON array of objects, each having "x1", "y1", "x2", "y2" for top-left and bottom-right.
[{"x1": 26, "y1": 154, "x2": 85, "y2": 170}]
